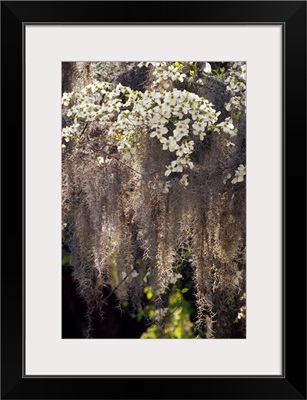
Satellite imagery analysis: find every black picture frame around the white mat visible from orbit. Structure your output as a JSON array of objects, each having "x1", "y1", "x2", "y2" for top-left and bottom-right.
[{"x1": 1, "y1": 1, "x2": 306, "y2": 399}]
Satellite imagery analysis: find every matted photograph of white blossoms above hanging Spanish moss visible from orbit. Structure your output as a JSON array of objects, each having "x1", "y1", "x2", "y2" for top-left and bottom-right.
[{"x1": 59, "y1": 60, "x2": 248, "y2": 339}]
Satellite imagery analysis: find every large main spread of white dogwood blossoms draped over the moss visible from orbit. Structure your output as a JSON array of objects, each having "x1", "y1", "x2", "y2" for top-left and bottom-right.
[{"x1": 62, "y1": 81, "x2": 221, "y2": 184}]
